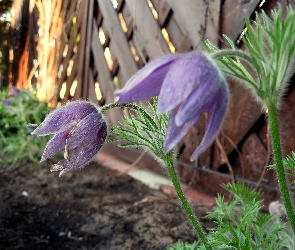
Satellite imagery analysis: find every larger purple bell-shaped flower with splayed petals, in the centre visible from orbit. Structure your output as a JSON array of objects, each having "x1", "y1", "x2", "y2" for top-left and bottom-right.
[{"x1": 115, "y1": 52, "x2": 229, "y2": 160}]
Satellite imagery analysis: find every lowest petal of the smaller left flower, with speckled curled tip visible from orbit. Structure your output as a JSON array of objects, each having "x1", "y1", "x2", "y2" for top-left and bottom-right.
[{"x1": 50, "y1": 123, "x2": 107, "y2": 176}]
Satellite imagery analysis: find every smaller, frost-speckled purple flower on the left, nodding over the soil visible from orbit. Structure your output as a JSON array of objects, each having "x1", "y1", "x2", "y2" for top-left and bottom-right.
[{"x1": 32, "y1": 101, "x2": 107, "y2": 175}]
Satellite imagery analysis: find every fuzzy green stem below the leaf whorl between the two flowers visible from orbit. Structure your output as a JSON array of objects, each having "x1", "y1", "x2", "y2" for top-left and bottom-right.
[{"x1": 165, "y1": 154, "x2": 212, "y2": 250}]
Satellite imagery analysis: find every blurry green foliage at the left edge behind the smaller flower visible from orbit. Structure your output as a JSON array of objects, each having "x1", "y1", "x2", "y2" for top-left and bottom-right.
[{"x1": 0, "y1": 89, "x2": 49, "y2": 172}]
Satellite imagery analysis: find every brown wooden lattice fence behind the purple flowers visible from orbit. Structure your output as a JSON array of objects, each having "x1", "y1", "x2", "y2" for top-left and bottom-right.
[{"x1": 13, "y1": 0, "x2": 295, "y2": 202}]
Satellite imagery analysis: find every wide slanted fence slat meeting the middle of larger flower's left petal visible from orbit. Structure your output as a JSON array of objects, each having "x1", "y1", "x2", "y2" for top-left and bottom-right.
[{"x1": 126, "y1": 0, "x2": 170, "y2": 59}]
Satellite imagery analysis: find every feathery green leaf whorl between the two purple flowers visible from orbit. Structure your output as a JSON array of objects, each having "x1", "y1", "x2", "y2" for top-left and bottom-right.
[{"x1": 109, "y1": 100, "x2": 173, "y2": 164}]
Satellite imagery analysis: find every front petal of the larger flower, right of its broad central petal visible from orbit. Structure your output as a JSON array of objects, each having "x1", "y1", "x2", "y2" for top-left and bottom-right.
[{"x1": 175, "y1": 74, "x2": 224, "y2": 126}]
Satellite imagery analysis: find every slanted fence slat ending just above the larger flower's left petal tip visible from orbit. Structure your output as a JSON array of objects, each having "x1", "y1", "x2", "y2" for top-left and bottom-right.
[{"x1": 98, "y1": 0, "x2": 137, "y2": 86}]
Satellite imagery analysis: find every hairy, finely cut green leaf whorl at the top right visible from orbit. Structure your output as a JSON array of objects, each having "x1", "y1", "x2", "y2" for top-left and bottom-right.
[{"x1": 204, "y1": 7, "x2": 295, "y2": 106}]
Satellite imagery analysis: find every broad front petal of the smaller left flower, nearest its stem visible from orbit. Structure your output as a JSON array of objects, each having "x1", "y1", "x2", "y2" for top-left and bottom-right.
[{"x1": 67, "y1": 111, "x2": 105, "y2": 150}]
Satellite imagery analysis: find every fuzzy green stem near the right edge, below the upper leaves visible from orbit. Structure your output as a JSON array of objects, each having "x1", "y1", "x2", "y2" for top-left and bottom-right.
[{"x1": 267, "y1": 103, "x2": 295, "y2": 233}]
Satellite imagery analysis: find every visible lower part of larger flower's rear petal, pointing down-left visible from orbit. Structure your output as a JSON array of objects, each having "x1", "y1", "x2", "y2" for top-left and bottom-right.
[{"x1": 164, "y1": 109, "x2": 199, "y2": 153}]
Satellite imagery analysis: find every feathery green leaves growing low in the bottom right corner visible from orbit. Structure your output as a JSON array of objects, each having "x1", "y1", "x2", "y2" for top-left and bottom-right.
[{"x1": 196, "y1": 183, "x2": 295, "y2": 250}]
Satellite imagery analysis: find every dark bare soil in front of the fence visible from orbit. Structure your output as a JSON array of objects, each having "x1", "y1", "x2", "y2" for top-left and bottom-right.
[{"x1": 0, "y1": 162, "x2": 210, "y2": 250}]
